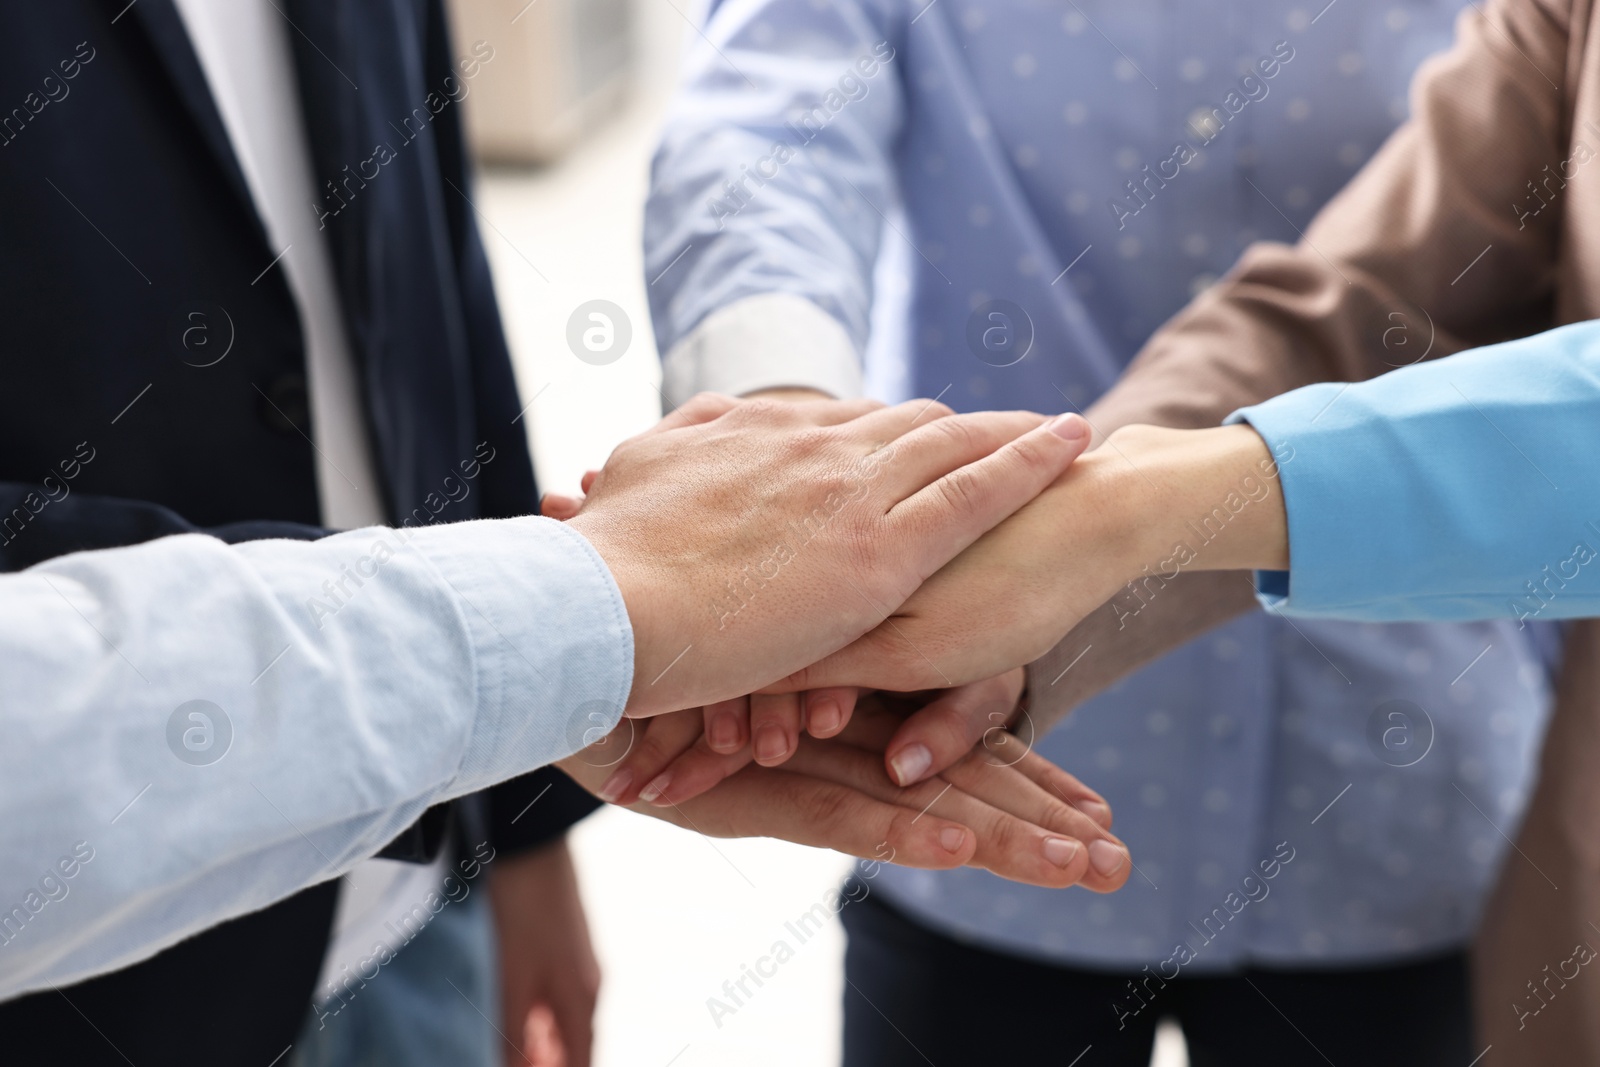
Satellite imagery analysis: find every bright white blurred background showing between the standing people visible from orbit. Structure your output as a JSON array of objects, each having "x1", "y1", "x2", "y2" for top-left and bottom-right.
[{"x1": 467, "y1": 0, "x2": 1187, "y2": 1067}]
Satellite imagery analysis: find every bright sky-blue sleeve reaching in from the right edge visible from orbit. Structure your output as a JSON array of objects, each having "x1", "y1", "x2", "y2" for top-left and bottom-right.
[{"x1": 1229, "y1": 322, "x2": 1600, "y2": 621}]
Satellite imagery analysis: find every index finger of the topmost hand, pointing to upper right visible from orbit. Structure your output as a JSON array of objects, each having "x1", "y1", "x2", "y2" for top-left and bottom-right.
[{"x1": 890, "y1": 414, "x2": 1090, "y2": 574}]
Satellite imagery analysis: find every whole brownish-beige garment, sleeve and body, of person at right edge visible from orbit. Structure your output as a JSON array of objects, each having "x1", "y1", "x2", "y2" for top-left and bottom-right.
[{"x1": 1030, "y1": 0, "x2": 1600, "y2": 1067}]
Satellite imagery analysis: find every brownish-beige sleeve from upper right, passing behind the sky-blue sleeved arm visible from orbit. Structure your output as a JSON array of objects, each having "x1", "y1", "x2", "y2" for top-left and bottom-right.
[{"x1": 1029, "y1": 0, "x2": 1574, "y2": 728}]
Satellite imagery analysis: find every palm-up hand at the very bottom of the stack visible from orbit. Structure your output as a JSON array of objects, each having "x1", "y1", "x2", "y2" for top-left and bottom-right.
[{"x1": 562, "y1": 687, "x2": 1131, "y2": 891}]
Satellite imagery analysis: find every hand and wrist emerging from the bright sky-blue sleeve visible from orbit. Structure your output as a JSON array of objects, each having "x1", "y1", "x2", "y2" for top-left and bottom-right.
[{"x1": 770, "y1": 426, "x2": 1288, "y2": 691}]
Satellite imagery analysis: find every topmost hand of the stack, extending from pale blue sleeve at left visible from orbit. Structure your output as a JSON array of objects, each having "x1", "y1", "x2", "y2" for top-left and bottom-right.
[{"x1": 556, "y1": 395, "x2": 1088, "y2": 715}]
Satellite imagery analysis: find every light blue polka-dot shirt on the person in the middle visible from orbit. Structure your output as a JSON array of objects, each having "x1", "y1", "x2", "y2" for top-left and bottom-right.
[{"x1": 645, "y1": 0, "x2": 1549, "y2": 973}]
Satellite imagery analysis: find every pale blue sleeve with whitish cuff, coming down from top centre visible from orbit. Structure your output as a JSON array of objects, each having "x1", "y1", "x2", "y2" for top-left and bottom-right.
[{"x1": 645, "y1": 0, "x2": 904, "y2": 402}]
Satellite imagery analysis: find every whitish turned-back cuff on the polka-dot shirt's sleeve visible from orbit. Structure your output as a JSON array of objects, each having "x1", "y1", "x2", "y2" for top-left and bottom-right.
[{"x1": 661, "y1": 293, "x2": 862, "y2": 405}]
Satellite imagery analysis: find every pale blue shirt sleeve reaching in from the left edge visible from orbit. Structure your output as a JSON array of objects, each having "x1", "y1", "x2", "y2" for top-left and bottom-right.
[{"x1": 0, "y1": 518, "x2": 634, "y2": 998}]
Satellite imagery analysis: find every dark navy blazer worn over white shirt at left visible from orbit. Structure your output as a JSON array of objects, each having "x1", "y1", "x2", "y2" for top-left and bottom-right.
[{"x1": 0, "y1": 0, "x2": 594, "y2": 1065}]
